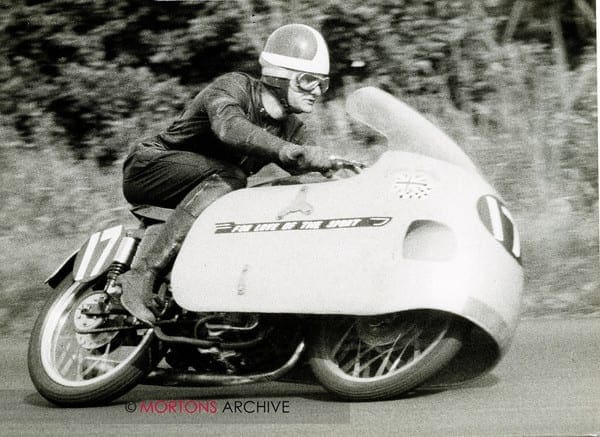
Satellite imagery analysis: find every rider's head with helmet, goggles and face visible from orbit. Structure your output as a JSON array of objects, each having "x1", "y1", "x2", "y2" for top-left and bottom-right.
[{"x1": 259, "y1": 24, "x2": 329, "y2": 113}]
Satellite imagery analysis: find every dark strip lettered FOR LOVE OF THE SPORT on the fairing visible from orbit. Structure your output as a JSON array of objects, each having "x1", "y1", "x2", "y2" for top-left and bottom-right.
[{"x1": 215, "y1": 217, "x2": 392, "y2": 234}]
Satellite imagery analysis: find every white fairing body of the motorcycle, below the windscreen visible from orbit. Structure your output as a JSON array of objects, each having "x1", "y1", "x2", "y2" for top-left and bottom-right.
[{"x1": 172, "y1": 152, "x2": 523, "y2": 347}]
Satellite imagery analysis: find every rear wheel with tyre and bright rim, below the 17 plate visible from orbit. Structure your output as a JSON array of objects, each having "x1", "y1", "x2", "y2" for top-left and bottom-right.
[{"x1": 27, "y1": 275, "x2": 160, "y2": 407}]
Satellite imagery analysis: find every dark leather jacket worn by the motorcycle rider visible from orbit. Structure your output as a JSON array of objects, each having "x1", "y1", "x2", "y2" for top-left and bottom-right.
[{"x1": 133, "y1": 73, "x2": 314, "y2": 174}]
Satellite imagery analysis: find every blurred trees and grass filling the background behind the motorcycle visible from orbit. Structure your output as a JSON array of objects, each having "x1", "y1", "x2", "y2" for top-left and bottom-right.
[{"x1": 0, "y1": 0, "x2": 600, "y2": 332}]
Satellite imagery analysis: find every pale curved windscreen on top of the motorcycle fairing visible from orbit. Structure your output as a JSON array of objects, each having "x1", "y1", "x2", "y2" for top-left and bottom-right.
[{"x1": 346, "y1": 87, "x2": 477, "y2": 172}]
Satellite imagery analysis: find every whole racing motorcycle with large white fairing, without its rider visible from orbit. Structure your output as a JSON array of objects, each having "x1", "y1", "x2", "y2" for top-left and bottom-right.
[{"x1": 28, "y1": 87, "x2": 523, "y2": 406}]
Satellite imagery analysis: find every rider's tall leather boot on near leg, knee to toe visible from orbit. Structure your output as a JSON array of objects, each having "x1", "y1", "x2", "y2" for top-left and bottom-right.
[{"x1": 118, "y1": 175, "x2": 234, "y2": 325}]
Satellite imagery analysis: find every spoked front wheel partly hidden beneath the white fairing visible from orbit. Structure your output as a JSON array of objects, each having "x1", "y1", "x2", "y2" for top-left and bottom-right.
[{"x1": 310, "y1": 311, "x2": 463, "y2": 401}]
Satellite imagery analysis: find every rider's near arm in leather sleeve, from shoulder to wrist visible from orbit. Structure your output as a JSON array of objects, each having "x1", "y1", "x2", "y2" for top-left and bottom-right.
[{"x1": 202, "y1": 77, "x2": 298, "y2": 161}]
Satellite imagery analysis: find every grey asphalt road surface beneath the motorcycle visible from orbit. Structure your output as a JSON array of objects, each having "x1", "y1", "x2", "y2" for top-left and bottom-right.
[{"x1": 0, "y1": 318, "x2": 600, "y2": 436}]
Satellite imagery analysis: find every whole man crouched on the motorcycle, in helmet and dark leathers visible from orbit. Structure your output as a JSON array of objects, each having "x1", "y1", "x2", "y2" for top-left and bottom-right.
[{"x1": 119, "y1": 24, "x2": 332, "y2": 324}]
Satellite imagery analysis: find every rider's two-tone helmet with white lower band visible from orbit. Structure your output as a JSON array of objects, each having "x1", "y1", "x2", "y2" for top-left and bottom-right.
[{"x1": 259, "y1": 24, "x2": 329, "y2": 79}]
